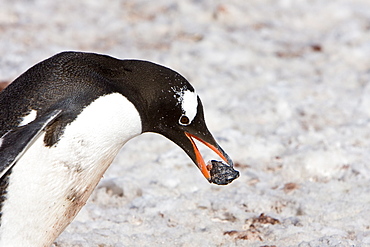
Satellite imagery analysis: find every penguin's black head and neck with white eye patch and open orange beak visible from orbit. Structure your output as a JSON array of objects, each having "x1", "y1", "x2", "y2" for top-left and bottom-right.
[{"x1": 116, "y1": 60, "x2": 239, "y2": 183}]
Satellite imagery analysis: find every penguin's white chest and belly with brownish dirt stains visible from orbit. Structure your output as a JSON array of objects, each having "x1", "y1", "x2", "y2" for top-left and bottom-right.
[{"x1": 0, "y1": 93, "x2": 141, "y2": 246}]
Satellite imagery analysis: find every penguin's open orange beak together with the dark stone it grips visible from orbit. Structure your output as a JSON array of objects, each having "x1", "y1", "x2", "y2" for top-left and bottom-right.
[{"x1": 185, "y1": 132, "x2": 239, "y2": 185}]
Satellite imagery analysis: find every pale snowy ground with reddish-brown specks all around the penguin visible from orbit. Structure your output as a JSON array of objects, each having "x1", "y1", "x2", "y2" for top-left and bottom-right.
[{"x1": 0, "y1": 0, "x2": 370, "y2": 247}]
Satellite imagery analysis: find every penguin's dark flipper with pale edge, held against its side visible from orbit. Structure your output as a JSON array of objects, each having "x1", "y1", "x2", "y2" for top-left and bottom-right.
[{"x1": 0, "y1": 110, "x2": 62, "y2": 179}]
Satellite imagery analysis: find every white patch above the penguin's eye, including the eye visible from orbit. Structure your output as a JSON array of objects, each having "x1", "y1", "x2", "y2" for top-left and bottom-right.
[{"x1": 179, "y1": 90, "x2": 198, "y2": 125}]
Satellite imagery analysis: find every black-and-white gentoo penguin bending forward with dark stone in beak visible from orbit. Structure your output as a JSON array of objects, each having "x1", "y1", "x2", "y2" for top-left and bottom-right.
[{"x1": 0, "y1": 52, "x2": 239, "y2": 247}]
